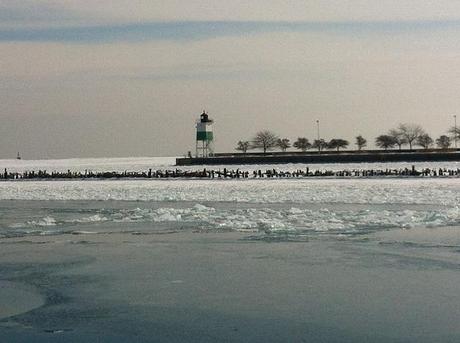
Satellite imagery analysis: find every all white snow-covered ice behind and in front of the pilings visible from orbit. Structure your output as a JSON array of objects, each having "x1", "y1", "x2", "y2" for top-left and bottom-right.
[{"x1": 0, "y1": 158, "x2": 460, "y2": 237}]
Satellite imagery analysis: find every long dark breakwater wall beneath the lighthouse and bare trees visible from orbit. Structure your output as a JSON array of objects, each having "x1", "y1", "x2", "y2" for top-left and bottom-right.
[{"x1": 176, "y1": 150, "x2": 460, "y2": 166}]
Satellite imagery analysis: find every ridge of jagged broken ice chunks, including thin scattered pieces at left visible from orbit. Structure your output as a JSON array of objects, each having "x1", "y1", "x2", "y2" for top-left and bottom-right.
[{"x1": 6, "y1": 202, "x2": 460, "y2": 241}]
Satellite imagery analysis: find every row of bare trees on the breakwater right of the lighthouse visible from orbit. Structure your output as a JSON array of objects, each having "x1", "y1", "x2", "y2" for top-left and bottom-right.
[{"x1": 236, "y1": 124, "x2": 460, "y2": 154}]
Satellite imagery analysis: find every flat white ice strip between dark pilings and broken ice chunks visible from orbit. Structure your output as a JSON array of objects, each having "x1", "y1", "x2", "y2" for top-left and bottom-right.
[{"x1": 0, "y1": 179, "x2": 460, "y2": 206}]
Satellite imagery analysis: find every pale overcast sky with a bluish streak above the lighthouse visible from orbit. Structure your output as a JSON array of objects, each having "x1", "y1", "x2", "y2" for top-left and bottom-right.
[{"x1": 0, "y1": 0, "x2": 460, "y2": 159}]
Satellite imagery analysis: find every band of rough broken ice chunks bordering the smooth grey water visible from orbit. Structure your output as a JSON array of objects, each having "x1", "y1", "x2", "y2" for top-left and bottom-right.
[{"x1": 15, "y1": 204, "x2": 460, "y2": 234}]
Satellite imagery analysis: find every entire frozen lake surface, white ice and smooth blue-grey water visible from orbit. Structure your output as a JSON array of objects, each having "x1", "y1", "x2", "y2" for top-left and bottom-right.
[{"x1": 0, "y1": 158, "x2": 460, "y2": 342}]
